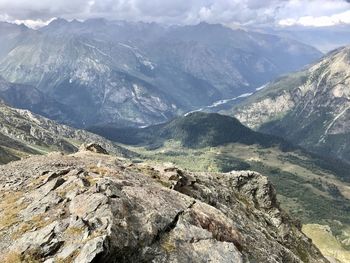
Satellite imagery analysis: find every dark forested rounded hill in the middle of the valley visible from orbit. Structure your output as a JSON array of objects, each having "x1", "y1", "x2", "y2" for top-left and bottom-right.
[{"x1": 90, "y1": 112, "x2": 291, "y2": 151}]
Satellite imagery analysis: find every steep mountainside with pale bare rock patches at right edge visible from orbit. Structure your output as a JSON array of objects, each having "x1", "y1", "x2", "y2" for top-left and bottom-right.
[{"x1": 233, "y1": 46, "x2": 350, "y2": 162}]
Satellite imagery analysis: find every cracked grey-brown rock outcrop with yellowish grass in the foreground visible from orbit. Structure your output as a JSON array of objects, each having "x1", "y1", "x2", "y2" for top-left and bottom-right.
[{"x1": 0, "y1": 154, "x2": 327, "y2": 263}]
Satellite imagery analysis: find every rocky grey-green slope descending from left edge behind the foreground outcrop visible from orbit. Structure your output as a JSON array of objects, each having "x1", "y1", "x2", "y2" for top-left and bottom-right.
[{"x1": 0, "y1": 102, "x2": 133, "y2": 164}]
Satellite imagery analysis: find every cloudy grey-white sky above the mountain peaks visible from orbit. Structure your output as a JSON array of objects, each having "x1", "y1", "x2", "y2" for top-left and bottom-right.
[{"x1": 0, "y1": 0, "x2": 350, "y2": 27}]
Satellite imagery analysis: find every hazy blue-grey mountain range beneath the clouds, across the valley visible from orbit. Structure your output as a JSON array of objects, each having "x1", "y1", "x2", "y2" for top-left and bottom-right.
[{"x1": 0, "y1": 19, "x2": 321, "y2": 127}]
